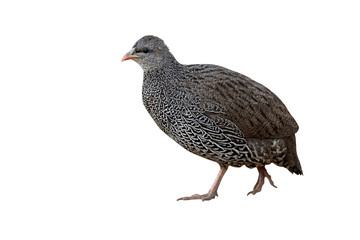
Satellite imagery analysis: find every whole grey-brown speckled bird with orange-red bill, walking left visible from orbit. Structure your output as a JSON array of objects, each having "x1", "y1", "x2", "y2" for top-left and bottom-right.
[{"x1": 122, "y1": 35, "x2": 303, "y2": 201}]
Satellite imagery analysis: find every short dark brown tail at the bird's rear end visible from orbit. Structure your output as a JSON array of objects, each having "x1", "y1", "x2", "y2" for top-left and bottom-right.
[{"x1": 284, "y1": 135, "x2": 303, "y2": 175}]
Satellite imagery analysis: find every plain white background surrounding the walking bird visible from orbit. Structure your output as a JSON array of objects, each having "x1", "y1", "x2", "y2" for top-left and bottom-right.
[{"x1": 0, "y1": 0, "x2": 360, "y2": 240}]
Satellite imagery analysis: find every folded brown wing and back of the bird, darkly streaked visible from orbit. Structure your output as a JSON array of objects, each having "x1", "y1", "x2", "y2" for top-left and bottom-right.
[{"x1": 183, "y1": 64, "x2": 299, "y2": 138}]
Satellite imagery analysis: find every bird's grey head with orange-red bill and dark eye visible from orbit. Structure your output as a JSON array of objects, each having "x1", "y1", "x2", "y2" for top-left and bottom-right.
[{"x1": 121, "y1": 35, "x2": 176, "y2": 70}]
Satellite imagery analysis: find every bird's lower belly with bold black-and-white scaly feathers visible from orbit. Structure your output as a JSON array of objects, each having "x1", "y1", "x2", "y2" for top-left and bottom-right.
[{"x1": 164, "y1": 110, "x2": 255, "y2": 166}]
